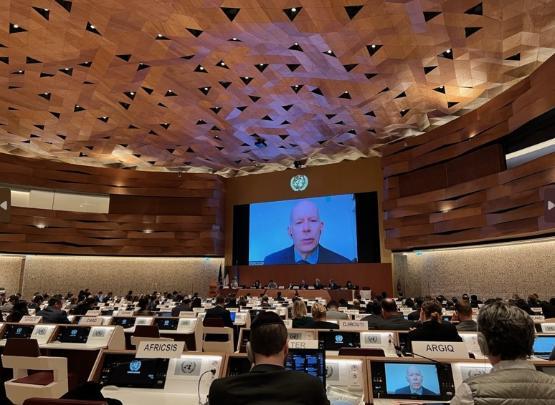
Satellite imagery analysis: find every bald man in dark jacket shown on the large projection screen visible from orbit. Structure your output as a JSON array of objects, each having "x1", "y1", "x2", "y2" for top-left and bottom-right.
[{"x1": 264, "y1": 200, "x2": 351, "y2": 264}]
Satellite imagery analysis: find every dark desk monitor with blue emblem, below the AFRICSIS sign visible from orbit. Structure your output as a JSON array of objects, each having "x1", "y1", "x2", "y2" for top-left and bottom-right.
[{"x1": 100, "y1": 353, "x2": 169, "y2": 389}]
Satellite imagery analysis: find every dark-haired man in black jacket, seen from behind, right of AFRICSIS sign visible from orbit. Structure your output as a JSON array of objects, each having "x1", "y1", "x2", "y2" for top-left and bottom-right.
[{"x1": 208, "y1": 312, "x2": 329, "y2": 405}]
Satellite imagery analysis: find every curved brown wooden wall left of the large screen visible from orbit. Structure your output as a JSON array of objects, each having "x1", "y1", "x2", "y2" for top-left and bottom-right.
[{"x1": 0, "y1": 154, "x2": 224, "y2": 256}]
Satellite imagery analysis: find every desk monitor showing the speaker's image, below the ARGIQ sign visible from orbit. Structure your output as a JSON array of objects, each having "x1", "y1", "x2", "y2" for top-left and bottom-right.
[{"x1": 371, "y1": 361, "x2": 455, "y2": 401}]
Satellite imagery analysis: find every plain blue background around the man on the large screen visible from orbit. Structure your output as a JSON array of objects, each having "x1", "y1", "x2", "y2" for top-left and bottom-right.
[{"x1": 249, "y1": 194, "x2": 357, "y2": 264}]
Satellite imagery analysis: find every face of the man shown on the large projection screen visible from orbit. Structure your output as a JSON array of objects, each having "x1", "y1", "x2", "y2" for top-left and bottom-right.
[{"x1": 289, "y1": 201, "x2": 324, "y2": 255}]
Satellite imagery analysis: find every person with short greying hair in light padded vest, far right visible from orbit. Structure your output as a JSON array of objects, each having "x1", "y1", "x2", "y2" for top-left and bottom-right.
[{"x1": 451, "y1": 302, "x2": 555, "y2": 405}]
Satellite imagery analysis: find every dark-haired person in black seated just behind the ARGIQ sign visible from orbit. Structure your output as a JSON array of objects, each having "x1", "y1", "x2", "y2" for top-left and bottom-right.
[{"x1": 408, "y1": 300, "x2": 462, "y2": 342}]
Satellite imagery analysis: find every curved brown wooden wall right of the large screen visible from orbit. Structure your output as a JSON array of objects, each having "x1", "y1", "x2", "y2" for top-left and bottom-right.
[{"x1": 382, "y1": 53, "x2": 555, "y2": 250}]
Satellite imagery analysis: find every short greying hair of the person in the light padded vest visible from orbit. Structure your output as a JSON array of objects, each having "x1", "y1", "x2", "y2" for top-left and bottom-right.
[{"x1": 478, "y1": 301, "x2": 535, "y2": 360}]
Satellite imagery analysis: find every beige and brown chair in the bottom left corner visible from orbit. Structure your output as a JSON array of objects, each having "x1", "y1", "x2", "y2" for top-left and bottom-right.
[{"x1": 2, "y1": 339, "x2": 69, "y2": 405}]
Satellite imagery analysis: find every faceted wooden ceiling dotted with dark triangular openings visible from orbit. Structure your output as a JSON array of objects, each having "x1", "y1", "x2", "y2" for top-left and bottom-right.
[{"x1": 0, "y1": 0, "x2": 555, "y2": 176}]
